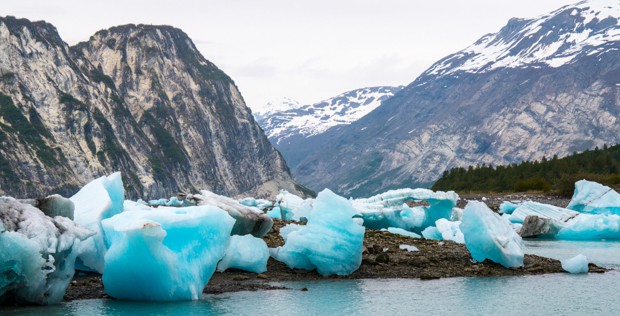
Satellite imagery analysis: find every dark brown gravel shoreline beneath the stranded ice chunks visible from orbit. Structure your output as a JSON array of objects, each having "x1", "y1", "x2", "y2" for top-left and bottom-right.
[{"x1": 64, "y1": 215, "x2": 607, "y2": 301}]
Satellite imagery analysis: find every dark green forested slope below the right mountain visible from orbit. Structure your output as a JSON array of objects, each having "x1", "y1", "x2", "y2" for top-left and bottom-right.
[{"x1": 433, "y1": 145, "x2": 620, "y2": 196}]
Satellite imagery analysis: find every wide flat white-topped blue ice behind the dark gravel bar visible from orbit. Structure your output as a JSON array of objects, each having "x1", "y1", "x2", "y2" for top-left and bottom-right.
[{"x1": 351, "y1": 189, "x2": 459, "y2": 233}]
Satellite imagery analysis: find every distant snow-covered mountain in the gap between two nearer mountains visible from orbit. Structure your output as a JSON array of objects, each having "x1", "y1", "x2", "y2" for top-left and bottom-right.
[{"x1": 255, "y1": 86, "x2": 403, "y2": 166}]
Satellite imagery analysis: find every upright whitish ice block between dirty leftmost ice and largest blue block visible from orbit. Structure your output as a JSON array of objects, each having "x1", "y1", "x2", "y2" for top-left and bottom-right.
[{"x1": 70, "y1": 172, "x2": 125, "y2": 273}]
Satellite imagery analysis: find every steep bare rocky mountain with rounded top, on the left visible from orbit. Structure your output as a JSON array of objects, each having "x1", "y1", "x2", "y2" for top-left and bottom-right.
[{"x1": 0, "y1": 17, "x2": 303, "y2": 197}]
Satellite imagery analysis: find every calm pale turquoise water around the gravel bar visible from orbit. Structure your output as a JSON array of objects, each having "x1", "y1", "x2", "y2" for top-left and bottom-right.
[{"x1": 0, "y1": 241, "x2": 620, "y2": 316}]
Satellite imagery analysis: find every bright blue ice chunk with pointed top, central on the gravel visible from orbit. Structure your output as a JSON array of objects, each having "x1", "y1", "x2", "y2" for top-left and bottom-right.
[{"x1": 271, "y1": 189, "x2": 364, "y2": 275}]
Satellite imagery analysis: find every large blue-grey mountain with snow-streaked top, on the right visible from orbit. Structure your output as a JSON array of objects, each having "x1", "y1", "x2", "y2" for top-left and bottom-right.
[{"x1": 293, "y1": 0, "x2": 620, "y2": 196}]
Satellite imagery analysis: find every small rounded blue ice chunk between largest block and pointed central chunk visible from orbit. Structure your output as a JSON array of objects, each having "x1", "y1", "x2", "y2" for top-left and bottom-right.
[{"x1": 217, "y1": 235, "x2": 269, "y2": 273}]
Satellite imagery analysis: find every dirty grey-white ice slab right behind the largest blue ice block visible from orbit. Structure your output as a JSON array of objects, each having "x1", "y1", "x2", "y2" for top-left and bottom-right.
[{"x1": 186, "y1": 190, "x2": 273, "y2": 238}]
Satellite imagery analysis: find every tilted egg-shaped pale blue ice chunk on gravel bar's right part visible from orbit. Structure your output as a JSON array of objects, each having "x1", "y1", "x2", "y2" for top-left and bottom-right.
[{"x1": 460, "y1": 201, "x2": 524, "y2": 268}]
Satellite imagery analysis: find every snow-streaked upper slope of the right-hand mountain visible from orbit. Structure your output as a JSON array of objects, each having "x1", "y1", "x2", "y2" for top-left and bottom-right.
[{"x1": 425, "y1": 0, "x2": 620, "y2": 76}]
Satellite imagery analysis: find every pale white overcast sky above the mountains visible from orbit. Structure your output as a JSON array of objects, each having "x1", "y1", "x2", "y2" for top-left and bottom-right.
[{"x1": 0, "y1": 0, "x2": 576, "y2": 109}]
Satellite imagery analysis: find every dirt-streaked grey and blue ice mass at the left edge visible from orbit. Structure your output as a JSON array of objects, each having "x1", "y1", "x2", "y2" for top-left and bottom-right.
[{"x1": 0, "y1": 197, "x2": 94, "y2": 304}]
